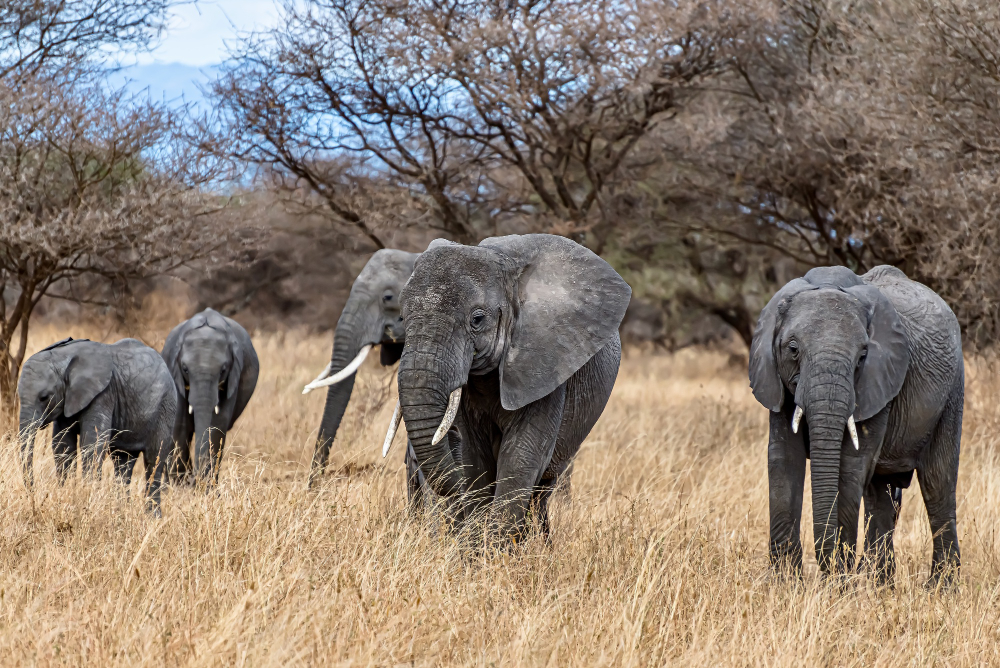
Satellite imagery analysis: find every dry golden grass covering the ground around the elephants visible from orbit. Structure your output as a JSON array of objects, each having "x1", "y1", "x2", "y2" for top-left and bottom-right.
[{"x1": 0, "y1": 322, "x2": 1000, "y2": 666}]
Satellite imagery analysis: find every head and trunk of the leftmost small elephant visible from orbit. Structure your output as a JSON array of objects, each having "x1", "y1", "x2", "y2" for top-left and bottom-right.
[{"x1": 17, "y1": 338, "x2": 113, "y2": 487}]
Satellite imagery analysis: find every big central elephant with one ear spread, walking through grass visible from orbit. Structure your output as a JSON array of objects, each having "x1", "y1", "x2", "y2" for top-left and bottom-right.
[{"x1": 399, "y1": 234, "x2": 631, "y2": 535}]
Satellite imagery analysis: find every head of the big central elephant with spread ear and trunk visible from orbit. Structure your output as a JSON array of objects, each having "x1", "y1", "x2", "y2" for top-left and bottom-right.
[{"x1": 387, "y1": 234, "x2": 631, "y2": 495}]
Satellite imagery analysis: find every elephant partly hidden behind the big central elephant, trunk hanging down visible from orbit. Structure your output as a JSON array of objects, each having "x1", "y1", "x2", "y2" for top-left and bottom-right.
[{"x1": 309, "y1": 249, "x2": 420, "y2": 488}]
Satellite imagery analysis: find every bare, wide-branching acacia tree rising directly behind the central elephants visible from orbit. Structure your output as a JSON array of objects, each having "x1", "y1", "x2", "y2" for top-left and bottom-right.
[{"x1": 213, "y1": 0, "x2": 729, "y2": 247}]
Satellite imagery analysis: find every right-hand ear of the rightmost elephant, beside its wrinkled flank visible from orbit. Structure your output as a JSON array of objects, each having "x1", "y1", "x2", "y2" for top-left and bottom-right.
[{"x1": 845, "y1": 285, "x2": 910, "y2": 422}]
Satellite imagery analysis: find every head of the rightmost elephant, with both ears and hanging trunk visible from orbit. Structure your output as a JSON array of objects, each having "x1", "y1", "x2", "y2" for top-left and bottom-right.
[{"x1": 750, "y1": 267, "x2": 909, "y2": 572}]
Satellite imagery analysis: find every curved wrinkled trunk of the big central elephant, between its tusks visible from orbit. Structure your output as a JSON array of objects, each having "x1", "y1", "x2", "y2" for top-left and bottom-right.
[{"x1": 399, "y1": 341, "x2": 468, "y2": 496}]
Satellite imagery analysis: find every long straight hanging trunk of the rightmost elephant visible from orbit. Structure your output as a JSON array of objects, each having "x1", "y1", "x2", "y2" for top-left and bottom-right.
[{"x1": 799, "y1": 363, "x2": 855, "y2": 573}]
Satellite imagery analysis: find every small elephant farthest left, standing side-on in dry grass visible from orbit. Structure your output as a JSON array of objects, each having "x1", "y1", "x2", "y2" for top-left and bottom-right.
[{"x1": 17, "y1": 339, "x2": 177, "y2": 515}]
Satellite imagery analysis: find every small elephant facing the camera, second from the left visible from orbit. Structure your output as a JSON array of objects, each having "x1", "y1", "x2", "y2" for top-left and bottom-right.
[{"x1": 162, "y1": 308, "x2": 260, "y2": 485}]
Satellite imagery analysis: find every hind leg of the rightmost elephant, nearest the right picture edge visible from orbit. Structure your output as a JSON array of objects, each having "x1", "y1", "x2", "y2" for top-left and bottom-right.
[{"x1": 917, "y1": 385, "x2": 964, "y2": 586}]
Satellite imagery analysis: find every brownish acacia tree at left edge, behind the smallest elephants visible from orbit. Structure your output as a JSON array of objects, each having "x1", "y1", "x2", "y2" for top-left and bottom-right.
[{"x1": 0, "y1": 0, "x2": 238, "y2": 413}]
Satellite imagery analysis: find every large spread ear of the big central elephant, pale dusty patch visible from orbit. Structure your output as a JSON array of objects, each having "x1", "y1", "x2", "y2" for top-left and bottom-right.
[{"x1": 480, "y1": 234, "x2": 632, "y2": 410}]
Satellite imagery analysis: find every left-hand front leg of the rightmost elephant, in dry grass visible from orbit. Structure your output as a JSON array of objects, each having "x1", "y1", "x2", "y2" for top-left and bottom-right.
[{"x1": 767, "y1": 408, "x2": 806, "y2": 575}]
